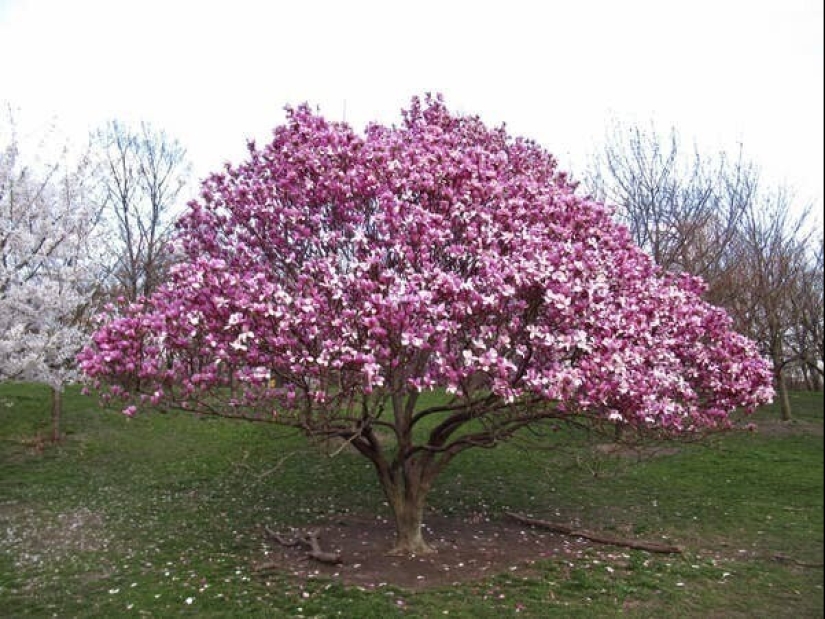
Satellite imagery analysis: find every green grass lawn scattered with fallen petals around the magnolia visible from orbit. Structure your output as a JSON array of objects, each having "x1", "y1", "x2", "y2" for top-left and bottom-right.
[{"x1": 0, "y1": 385, "x2": 823, "y2": 618}]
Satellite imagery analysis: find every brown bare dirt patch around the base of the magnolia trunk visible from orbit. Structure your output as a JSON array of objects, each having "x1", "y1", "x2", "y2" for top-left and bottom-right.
[{"x1": 257, "y1": 516, "x2": 593, "y2": 590}]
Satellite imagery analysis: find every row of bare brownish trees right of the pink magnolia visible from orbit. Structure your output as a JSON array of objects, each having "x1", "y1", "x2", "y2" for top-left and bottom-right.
[{"x1": 583, "y1": 123, "x2": 825, "y2": 419}]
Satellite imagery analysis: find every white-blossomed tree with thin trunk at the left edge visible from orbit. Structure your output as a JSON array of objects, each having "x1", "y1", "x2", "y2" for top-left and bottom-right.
[{"x1": 0, "y1": 114, "x2": 102, "y2": 440}]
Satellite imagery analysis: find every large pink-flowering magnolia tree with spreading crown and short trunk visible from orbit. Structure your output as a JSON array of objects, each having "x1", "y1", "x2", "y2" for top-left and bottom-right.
[{"x1": 81, "y1": 97, "x2": 772, "y2": 553}]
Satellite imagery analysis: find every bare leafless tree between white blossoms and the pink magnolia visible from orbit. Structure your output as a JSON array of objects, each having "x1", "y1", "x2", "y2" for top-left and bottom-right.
[{"x1": 94, "y1": 121, "x2": 190, "y2": 299}]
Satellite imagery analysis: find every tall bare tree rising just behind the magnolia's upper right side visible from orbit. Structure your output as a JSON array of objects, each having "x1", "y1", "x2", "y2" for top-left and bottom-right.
[{"x1": 584, "y1": 123, "x2": 758, "y2": 304}]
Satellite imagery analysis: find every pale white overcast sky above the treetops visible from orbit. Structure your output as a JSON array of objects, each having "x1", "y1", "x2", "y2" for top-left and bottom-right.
[{"x1": 0, "y1": 0, "x2": 825, "y2": 228}]
